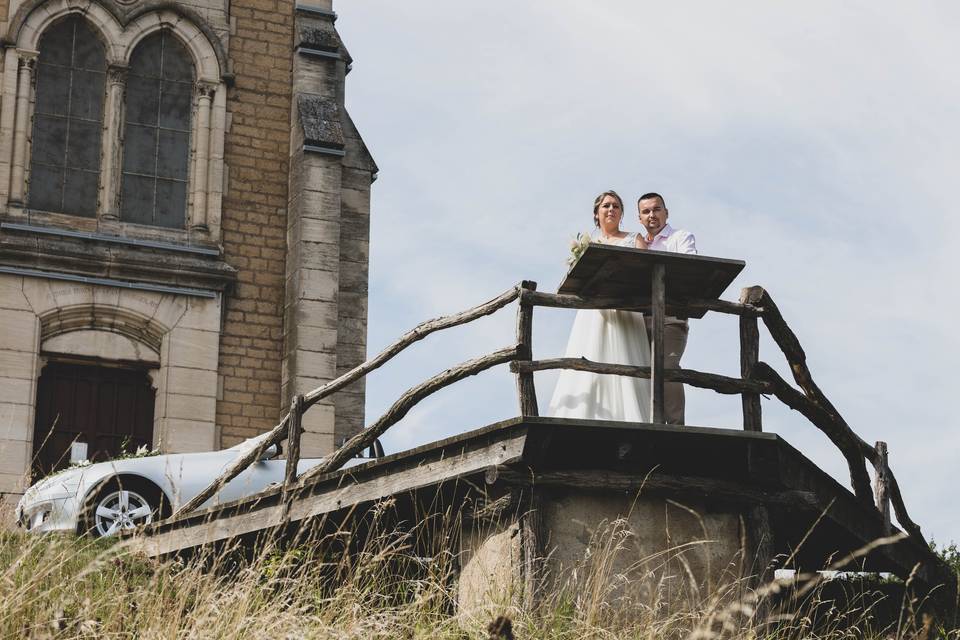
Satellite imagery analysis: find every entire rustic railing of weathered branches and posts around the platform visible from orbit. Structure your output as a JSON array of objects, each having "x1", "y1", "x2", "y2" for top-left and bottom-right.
[{"x1": 173, "y1": 281, "x2": 927, "y2": 547}]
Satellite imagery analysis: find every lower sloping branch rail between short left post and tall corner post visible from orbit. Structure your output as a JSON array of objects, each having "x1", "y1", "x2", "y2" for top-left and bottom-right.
[{"x1": 300, "y1": 345, "x2": 520, "y2": 483}]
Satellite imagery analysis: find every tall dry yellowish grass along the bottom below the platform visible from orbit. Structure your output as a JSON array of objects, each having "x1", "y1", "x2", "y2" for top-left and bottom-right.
[{"x1": 0, "y1": 523, "x2": 960, "y2": 640}]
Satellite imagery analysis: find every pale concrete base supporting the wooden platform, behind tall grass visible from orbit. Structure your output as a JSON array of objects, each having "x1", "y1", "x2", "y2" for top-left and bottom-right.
[{"x1": 457, "y1": 488, "x2": 754, "y2": 620}]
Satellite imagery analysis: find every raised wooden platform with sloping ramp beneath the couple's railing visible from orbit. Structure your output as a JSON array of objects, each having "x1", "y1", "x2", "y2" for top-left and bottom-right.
[{"x1": 130, "y1": 418, "x2": 944, "y2": 588}]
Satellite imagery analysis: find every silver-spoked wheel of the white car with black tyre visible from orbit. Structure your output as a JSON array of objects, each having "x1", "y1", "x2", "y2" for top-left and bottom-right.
[{"x1": 81, "y1": 479, "x2": 166, "y2": 538}]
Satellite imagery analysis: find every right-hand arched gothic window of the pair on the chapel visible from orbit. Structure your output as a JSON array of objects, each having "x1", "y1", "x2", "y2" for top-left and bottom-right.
[{"x1": 120, "y1": 31, "x2": 194, "y2": 228}]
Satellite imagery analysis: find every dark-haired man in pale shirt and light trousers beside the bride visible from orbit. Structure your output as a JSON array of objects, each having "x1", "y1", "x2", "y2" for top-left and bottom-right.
[{"x1": 637, "y1": 193, "x2": 697, "y2": 424}]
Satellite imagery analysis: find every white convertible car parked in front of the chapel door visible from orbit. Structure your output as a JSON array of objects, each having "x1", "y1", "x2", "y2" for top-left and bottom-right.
[{"x1": 15, "y1": 435, "x2": 382, "y2": 537}]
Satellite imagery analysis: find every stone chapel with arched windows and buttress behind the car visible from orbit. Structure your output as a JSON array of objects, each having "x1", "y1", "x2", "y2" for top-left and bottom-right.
[{"x1": 0, "y1": 0, "x2": 377, "y2": 504}]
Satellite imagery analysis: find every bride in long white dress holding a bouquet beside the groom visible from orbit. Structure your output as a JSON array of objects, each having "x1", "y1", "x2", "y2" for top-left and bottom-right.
[{"x1": 549, "y1": 191, "x2": 650, "y2": 422}]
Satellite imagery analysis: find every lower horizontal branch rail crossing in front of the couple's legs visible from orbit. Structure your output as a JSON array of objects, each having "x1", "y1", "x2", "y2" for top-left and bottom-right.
[{"x1": 510, "y1": 358, "x2": 770, "y2": 394}]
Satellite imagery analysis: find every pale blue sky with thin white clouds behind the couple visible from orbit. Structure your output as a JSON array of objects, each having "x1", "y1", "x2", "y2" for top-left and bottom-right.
[{"x1": 334, "y1": 0, "x2": 960, "y2": 543}]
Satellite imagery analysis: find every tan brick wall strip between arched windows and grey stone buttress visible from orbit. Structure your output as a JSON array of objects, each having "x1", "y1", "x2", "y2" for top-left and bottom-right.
[{"x1": 217, "y1": 0, "x2": 293, "y2": 446}]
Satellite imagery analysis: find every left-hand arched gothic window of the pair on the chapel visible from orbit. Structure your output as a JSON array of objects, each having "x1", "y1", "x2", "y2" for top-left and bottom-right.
[{"x1": 28, "y1": 16, "x2": 107, "y2": 216}]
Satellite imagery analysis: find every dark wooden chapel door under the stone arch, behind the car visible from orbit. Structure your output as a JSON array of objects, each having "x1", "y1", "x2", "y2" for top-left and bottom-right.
[{"x1": 33, "y1": 362, "x2": 154, "y2": 478}]
